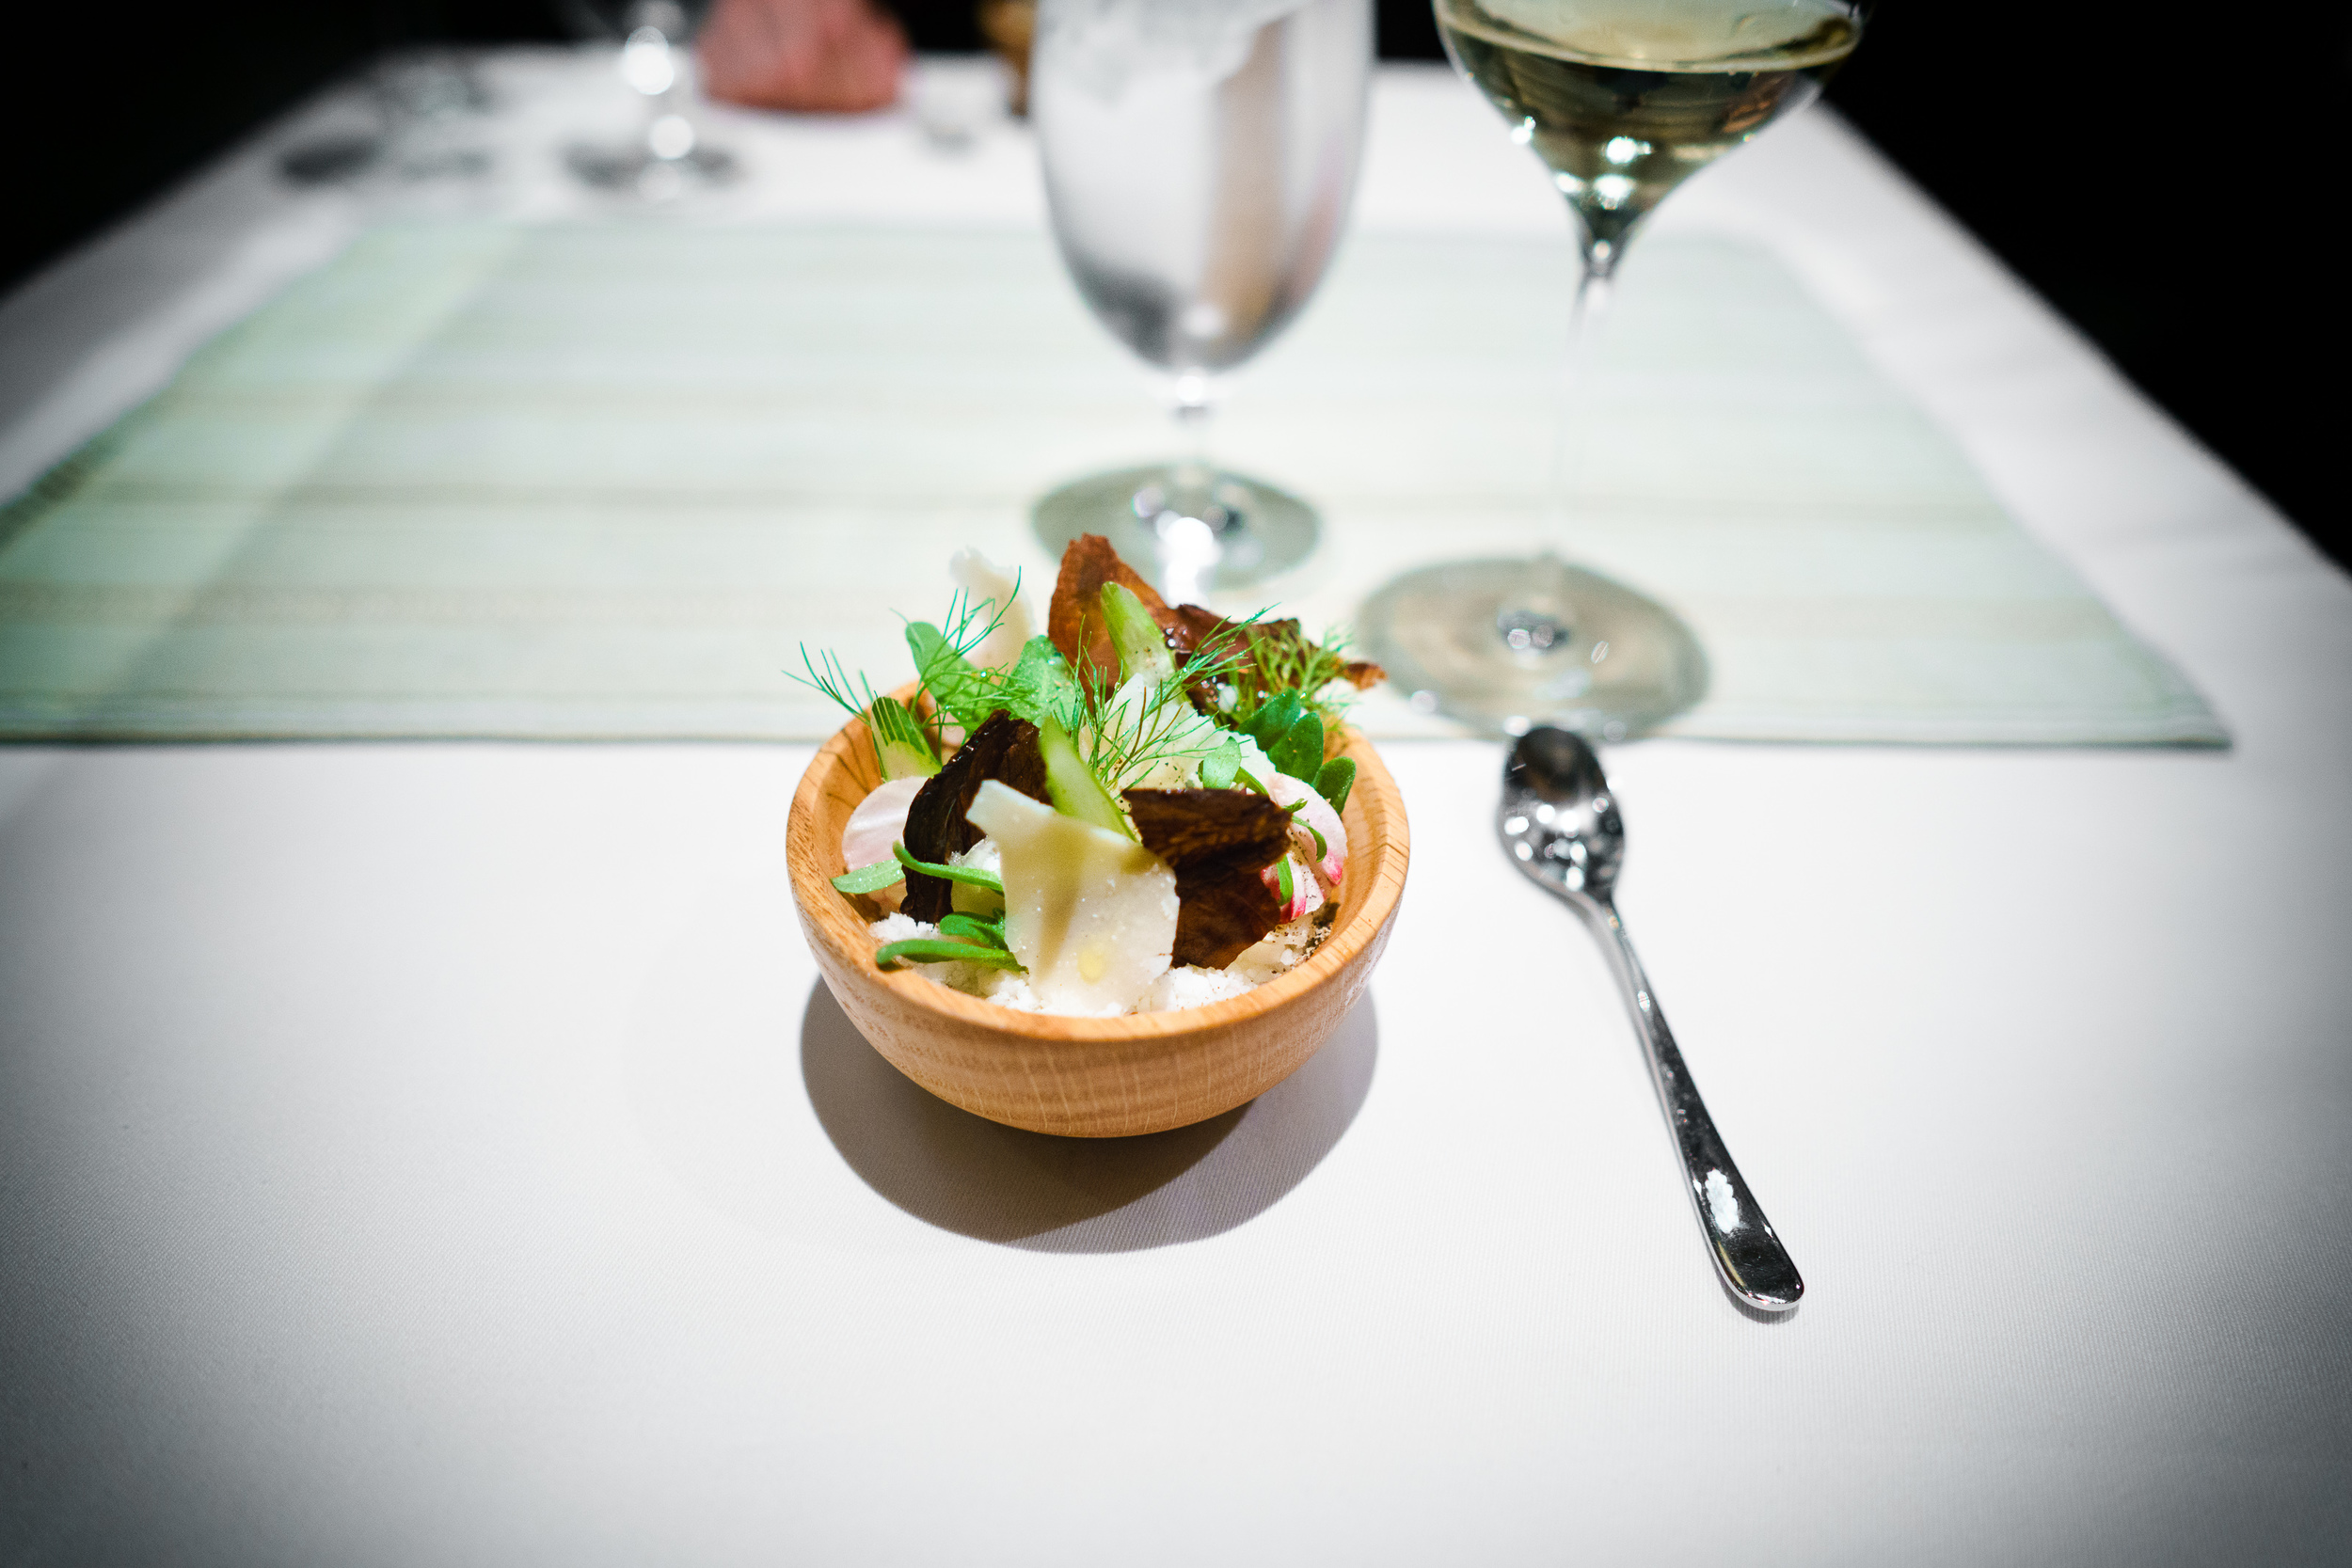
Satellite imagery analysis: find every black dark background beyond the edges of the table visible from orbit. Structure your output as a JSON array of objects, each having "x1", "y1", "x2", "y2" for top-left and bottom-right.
[{"x1": 0, "y1": 0, "x2": 2352, "y2": 564}]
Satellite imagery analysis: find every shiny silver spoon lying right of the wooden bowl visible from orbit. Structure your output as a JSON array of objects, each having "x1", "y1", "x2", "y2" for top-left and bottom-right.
[{"x1": 1494, "y1": 729, "x2": 1804, "y2": 1312}]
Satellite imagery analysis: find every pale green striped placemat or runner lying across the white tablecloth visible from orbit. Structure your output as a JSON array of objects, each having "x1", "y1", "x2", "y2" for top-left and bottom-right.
[{"x1": 0, "y1": 226, "x2": 2225, "y2": 743}]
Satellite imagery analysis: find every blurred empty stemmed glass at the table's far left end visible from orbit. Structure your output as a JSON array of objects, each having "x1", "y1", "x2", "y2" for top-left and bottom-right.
[{"x1": 560, "y1": 0, "x2": 737, "y2": 202}]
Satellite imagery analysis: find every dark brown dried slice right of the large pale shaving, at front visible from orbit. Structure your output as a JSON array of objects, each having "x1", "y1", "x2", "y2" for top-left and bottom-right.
[{"x1": 1127, "y1": 790, "x2": 1292, "y2": 969}]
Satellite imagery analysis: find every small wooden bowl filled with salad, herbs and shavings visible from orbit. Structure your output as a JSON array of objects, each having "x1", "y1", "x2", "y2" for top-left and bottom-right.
[{"x1": 788, "y1": 536, "x2": 1406, "y2": 1133}]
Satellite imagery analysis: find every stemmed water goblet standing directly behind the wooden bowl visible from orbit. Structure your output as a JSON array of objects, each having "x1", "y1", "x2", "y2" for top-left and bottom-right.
[{"x1": 1030, "y1": 0, "x2": 1372, "y2": 599}]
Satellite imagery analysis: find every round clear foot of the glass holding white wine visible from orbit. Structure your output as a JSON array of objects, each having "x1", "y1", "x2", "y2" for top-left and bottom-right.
[{"x1": 1355, "y1": 555, "x2": 1708, "y2": 740}]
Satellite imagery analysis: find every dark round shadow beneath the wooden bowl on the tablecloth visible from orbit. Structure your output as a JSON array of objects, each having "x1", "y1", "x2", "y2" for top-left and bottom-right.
[{"x1": 800, "y1": 983, "x2": 1381, "y2": 1253}]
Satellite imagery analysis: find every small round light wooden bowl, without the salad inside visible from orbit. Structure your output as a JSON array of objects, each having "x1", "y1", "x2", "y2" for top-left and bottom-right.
[{"x1": 786, "y1": 691, "x2": 1409, "y2": 1138}]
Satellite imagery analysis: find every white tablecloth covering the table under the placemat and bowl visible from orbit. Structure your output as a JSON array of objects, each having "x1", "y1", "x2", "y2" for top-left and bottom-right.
[{"x1": 0, "y1": 54, "x2": 2352, "y2": 1566}]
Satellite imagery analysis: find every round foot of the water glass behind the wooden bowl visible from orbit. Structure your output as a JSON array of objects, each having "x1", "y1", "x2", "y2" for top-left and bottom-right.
[{"x1": 1033, "y1": 463, "x2": 1322, "y2": 604}]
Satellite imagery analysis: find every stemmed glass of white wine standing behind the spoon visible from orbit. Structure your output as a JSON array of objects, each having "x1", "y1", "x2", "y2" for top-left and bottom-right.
[{"x1": 1358, "y1": 0, "x2": 1870, "y2": 740}]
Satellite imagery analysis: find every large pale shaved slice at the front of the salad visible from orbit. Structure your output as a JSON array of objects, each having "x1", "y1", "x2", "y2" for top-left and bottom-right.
[{"x1": 964, "y1": 778, "x2": 1176, "y2": 1016}]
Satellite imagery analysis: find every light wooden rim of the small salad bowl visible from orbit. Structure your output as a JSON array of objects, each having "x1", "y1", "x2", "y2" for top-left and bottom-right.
[{"x1": 786, "y1": 682, "x2": 1411, "y2": 1044}]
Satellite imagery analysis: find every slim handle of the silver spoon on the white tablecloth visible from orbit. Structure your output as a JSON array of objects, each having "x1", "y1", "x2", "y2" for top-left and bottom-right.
[{"x1": 1574, "y1": 894, "x2": 1804, "y2": 1312}]
